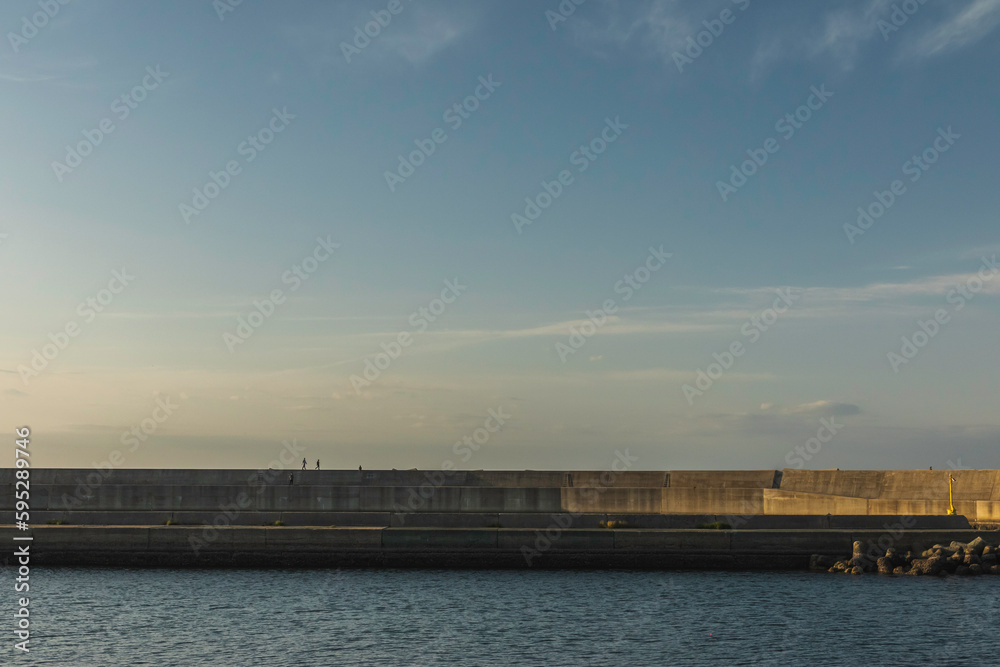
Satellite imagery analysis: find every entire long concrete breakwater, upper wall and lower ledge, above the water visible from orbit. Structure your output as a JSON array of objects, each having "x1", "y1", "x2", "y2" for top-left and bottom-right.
[{"x1": 0, "y1": 469, "x2": 1000, "y2": 569}]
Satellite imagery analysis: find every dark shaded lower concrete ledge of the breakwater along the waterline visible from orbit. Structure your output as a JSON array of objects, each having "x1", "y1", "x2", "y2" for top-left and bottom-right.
[{"x1": 0, "y1": 525, "x2": 997, "y2": 570}]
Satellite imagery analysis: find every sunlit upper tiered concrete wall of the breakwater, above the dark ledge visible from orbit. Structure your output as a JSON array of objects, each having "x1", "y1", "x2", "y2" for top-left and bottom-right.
[{"x1": 7, "y1": 468, "x2": 1000, "y2": 525}]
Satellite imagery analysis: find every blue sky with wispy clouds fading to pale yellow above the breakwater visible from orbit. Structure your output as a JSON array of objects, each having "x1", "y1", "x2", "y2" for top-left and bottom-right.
[{"x1": 0, "y1": 0, "x2": 1000, "y2": 470}]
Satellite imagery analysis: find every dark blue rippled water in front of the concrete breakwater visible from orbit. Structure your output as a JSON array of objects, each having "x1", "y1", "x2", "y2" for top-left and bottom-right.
[{"x1": 0, "y1": 568, "x2": 1000, "y2": 666}]
